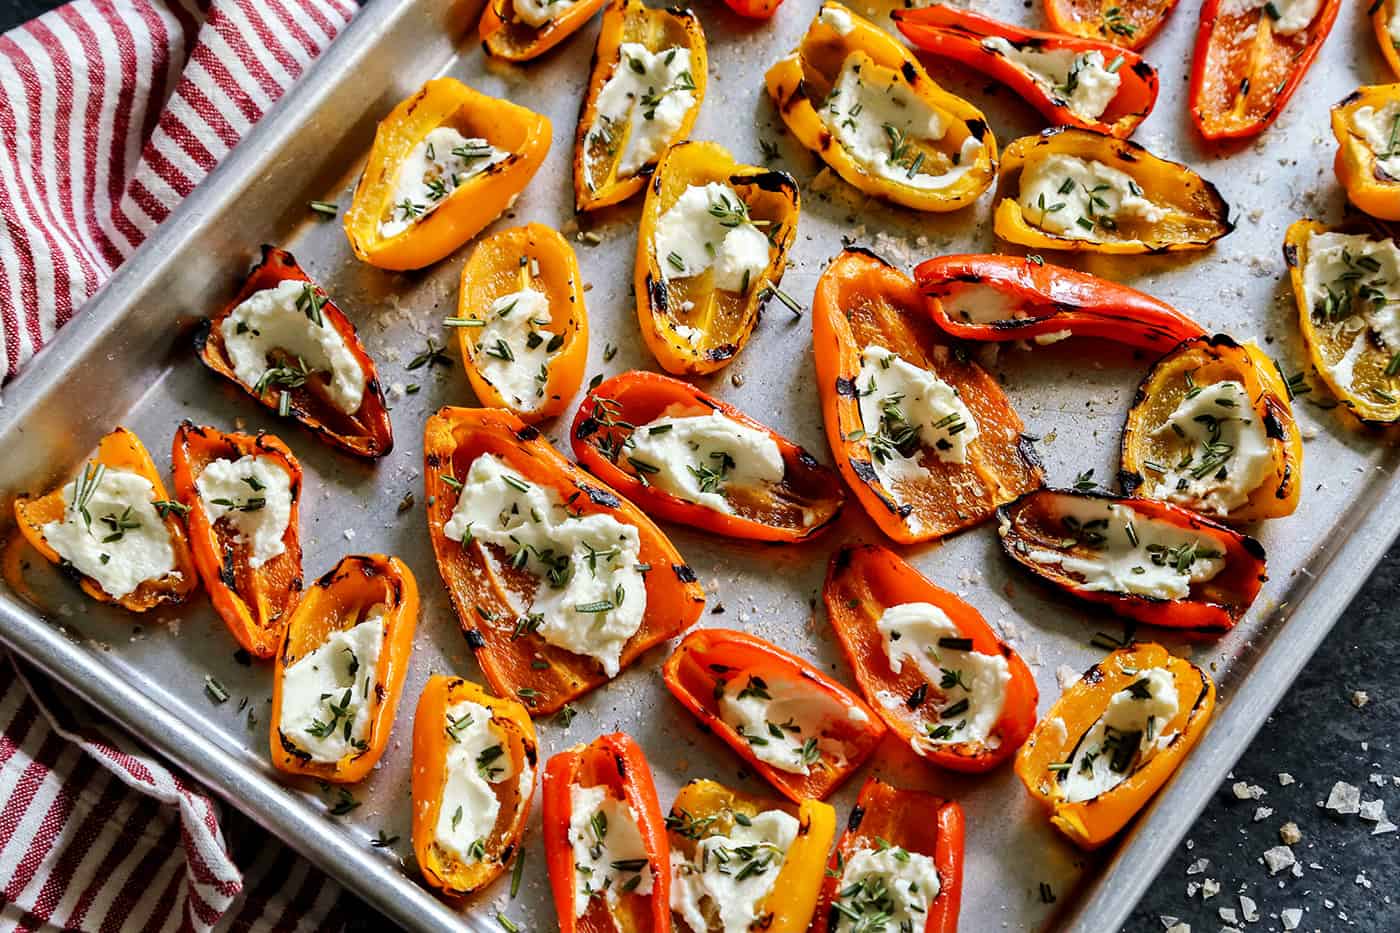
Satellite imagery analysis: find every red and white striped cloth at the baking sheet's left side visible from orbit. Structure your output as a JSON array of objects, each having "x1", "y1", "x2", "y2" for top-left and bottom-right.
[{"x1": 0, "y1": 0, "x2": 357, "y2": 933}]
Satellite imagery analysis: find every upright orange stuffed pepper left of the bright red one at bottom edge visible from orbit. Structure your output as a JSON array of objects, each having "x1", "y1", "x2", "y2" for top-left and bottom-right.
[{"x1": 413, "y1": 674, "x2": 539, "y2": 898}]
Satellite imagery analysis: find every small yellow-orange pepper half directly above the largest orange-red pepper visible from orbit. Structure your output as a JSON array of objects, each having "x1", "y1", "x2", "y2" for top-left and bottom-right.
[{"x1": 448, "y1": 224, "x2": 588, "y2": 422}]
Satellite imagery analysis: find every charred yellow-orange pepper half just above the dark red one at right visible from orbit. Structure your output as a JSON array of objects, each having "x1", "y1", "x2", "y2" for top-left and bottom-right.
[{"x1": 1119, "y1": 333, "x2": 1303, "y2": 523}]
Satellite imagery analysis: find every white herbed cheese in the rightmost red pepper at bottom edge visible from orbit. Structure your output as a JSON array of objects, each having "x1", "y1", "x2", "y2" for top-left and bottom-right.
[{"x1": 832, "y1": 840, "x2": 942, "y2": 933}]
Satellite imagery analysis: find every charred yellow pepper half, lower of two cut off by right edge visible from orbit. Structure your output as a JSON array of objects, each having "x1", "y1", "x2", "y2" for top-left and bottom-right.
[{"x1": 1284, "y1": 219, "x2": 1400, "y2": 427}]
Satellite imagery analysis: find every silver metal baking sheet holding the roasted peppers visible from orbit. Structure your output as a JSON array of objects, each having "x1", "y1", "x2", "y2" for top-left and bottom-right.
[{"x1": 0, "y1": 0, "x2": 1400, "y2": 933}]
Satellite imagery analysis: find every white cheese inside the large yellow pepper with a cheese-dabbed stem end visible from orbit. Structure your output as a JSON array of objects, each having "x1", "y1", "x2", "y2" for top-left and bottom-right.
[{"x1": 818, "y1": 52, "x2": 981, "y2": 191}]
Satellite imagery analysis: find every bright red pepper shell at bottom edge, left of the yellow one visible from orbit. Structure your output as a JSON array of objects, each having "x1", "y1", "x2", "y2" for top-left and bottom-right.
[{"x1": 543, "y1": 733, "x2": 671, "y2": 933}]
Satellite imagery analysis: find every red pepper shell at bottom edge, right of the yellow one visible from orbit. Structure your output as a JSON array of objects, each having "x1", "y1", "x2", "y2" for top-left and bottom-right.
[{"x1": 812, "y1": 778, "x2": 963, "y2": 933}]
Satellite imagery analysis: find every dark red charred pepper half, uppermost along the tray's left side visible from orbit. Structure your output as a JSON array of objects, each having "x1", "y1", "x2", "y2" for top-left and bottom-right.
[{"x1": 195, "y1": 245, "x2": 393, "y2": 457}]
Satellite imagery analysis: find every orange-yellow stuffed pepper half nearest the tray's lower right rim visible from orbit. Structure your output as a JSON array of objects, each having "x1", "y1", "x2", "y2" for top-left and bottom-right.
[{"x1": 1016, "y1": 644, "x2": 1215, "y2": 849}]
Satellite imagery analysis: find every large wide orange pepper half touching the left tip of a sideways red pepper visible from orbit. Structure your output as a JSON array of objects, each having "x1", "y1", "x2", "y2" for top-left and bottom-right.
[{"x1": 812, "y1": 249, "x2": 1044, "y2": 544}]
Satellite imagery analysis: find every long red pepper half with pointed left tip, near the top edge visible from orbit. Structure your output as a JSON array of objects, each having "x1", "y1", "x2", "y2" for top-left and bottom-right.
[{"x1": 890, "y1": 3, "x2": 1158, "y2": 139}]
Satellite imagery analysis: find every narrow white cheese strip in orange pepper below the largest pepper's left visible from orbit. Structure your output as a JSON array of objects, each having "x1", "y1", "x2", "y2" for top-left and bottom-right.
[{"x1": 434, "y1": 702, "x2": 515, "y2": 863}]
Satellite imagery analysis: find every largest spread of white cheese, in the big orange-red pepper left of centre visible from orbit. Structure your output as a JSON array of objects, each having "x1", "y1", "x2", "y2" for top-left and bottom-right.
[{"x1": 442, "y1": 454, "x2": 647, "y2": 677}]
